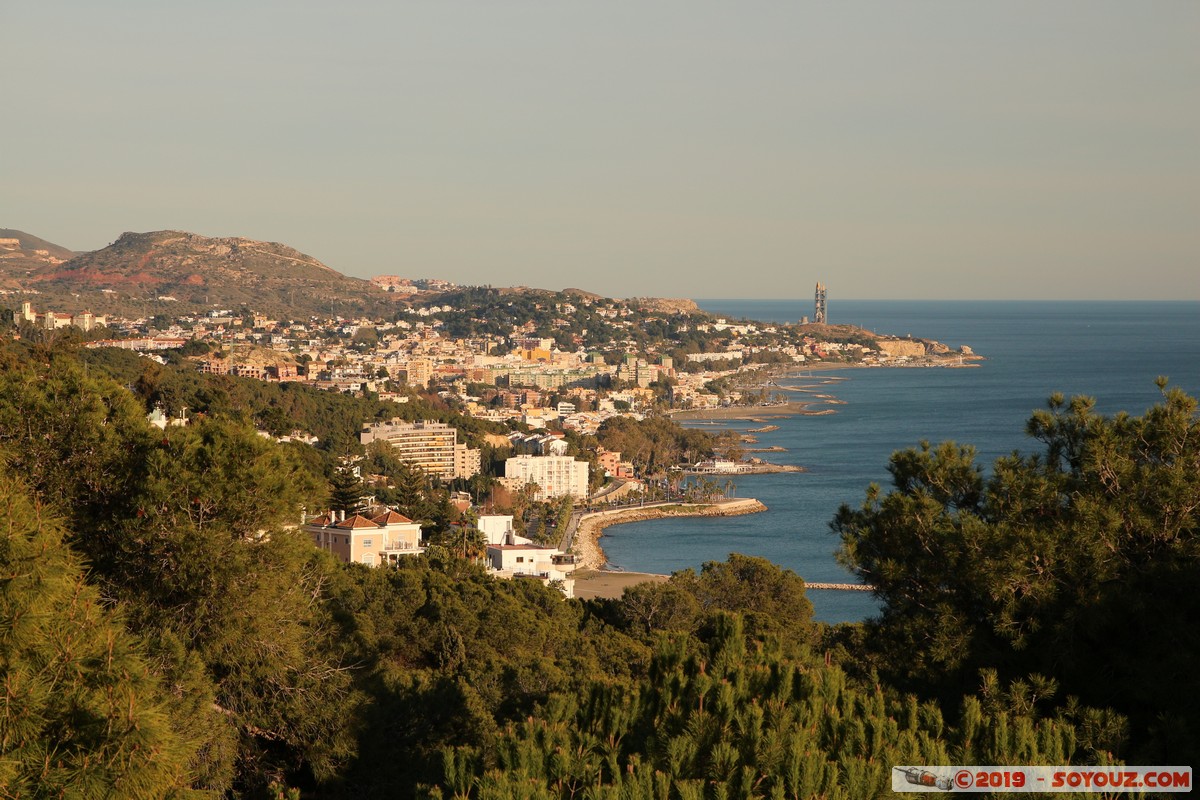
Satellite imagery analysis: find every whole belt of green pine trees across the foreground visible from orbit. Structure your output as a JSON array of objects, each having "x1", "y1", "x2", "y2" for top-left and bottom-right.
[{"x1": 0, "y1": 345, "x2": 1200, "y2": 800}]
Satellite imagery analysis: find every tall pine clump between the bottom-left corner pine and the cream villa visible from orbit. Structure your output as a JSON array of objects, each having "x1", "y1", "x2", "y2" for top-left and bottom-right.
[{"x1": 0, "y1": 347, "x2": 358, "y2": 787}]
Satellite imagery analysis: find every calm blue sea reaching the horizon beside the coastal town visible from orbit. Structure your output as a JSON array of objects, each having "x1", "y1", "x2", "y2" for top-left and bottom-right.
[{"x1": 600, "y1": 300, "x2": 1200, "y2": 622}]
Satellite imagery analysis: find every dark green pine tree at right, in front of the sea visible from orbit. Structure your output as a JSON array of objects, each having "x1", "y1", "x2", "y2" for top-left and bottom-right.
[{"x1": 833, "y1": 381, "x2": 1200, "y2": 763}]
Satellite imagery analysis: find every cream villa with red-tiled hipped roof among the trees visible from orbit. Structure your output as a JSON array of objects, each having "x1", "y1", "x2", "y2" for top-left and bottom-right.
[{"x1": 301, "y1": 509, "x2": 425, "y2": 566}]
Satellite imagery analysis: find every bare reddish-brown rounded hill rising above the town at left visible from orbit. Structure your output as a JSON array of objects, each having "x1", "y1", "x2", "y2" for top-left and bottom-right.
[{"x1": 16, "y1": 230, "x2": 394, "y2": 317}]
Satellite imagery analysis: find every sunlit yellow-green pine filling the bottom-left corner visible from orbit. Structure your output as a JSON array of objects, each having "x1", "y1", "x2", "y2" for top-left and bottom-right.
[{"x1": 0, "y1": 470, "x2": 205, "y2": 799}]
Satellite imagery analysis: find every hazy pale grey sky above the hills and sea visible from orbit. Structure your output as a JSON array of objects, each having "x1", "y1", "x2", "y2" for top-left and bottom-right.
[{"x1": 0, "y1": 0, "x2": 1200, "y2": 299}]
